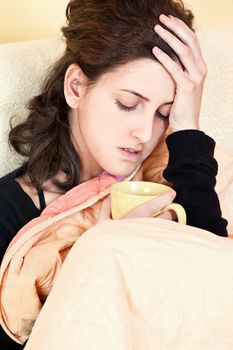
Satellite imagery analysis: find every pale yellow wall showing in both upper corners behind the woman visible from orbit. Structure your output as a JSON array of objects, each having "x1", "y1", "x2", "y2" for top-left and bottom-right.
[{"x1": 0, "y1": 0, "x2": 233, "y2": 43}]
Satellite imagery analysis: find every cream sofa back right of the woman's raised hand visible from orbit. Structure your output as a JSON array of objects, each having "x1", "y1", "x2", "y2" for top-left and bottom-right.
[{"x1": 199, "y1": 24, "x2": 233, "y2": 151}]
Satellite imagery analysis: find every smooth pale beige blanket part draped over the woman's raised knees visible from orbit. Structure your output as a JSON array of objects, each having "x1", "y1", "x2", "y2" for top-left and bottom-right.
[{"x1": 25, "y1": 219, "x2": 233, "y2": 350}]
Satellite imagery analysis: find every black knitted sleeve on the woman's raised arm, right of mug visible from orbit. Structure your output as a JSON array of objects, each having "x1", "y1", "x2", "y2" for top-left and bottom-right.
[{"x1": 163, "y1": 130, "x2": 227, "y2": 236}]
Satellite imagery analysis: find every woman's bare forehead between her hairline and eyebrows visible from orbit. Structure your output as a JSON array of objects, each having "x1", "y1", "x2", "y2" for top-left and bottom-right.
[{"x1": 96, "y1": 59, "x2": 175, "y2": 100}]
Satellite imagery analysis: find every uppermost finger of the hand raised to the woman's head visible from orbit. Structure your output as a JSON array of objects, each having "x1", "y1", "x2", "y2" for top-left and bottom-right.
[{"x1": 159, "y1": 15, "x2": 206, "y2": 73}]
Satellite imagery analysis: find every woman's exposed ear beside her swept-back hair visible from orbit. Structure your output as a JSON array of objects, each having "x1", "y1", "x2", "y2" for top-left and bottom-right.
[{"x1": 64, "y1": 63, "x2": 87, "y2": 108}]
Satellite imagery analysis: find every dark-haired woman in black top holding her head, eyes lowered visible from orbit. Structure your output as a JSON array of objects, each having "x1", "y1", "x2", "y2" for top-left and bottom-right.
[{"x1": 0, "y1": 0, "x2": 227, "y2": 349}]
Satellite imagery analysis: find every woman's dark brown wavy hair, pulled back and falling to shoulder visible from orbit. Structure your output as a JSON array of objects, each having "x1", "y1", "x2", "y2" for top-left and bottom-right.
[{"x1": 9, "y1": 0, "x2": 193, "y2": 191}]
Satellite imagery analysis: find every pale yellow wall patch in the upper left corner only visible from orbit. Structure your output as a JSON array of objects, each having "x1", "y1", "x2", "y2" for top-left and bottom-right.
[{"x1": 0, "y1": 0, "x2": 68, "y2": 43}]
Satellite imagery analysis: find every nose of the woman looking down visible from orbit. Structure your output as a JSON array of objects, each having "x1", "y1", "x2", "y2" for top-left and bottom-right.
[{"x1": 132, "y1": 116, "x2": 154, "y2": 143}]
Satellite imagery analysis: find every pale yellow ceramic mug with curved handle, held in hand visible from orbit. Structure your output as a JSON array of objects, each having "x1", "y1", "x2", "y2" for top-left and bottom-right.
[{"x1": 110, "y1": 181, "x2": 186, "y2": 225}]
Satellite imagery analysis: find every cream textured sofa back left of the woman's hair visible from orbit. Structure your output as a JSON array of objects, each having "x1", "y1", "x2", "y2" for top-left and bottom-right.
[{"x1": 0, "y1": 38, "x2": 64, "y2": 177}]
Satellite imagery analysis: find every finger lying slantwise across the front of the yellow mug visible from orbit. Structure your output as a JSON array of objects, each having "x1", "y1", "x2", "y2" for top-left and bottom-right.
[{"x1": 124, "y1": 190, "x2": 176, "y2": 219}]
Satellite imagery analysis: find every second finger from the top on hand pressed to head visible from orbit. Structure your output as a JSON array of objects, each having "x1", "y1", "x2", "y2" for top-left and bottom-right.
[{"x1": 155, "y1": 24, "x2": 199, "y2": 76}]
